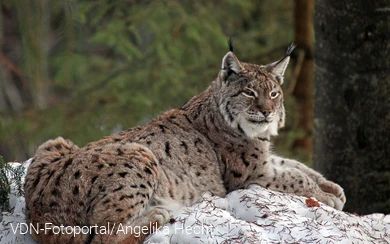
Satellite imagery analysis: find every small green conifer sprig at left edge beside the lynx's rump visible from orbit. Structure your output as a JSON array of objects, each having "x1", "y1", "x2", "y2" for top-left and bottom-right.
[{"x1": 0, "y1": 156, "x2": 24, "y2": 212}]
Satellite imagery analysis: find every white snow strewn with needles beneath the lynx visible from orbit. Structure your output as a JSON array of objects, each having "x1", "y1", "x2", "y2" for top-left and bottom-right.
[{"x1": 0, "y1": 161, "x2": 390, "y2": 244}]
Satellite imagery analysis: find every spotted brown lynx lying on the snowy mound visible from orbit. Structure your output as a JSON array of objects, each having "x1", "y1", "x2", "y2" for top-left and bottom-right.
[{"x1": 25, "y1": 43, "x2": 346, "y2": 244}]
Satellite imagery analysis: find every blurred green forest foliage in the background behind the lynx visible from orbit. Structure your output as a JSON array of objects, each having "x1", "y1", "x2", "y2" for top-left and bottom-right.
[{"x1": 0, "y1": 0, "x2": 293, "y2": 160}]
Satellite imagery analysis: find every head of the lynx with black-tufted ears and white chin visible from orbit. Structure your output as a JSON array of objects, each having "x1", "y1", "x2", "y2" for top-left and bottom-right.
[{"x1": 215, "y1": 45, "x2": 295, "y2": 138}]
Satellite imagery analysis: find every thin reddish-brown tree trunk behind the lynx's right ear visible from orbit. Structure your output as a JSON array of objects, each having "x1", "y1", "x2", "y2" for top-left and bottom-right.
[{"x1": 293, "y1": 0, "x2": 314, "y2": 154}]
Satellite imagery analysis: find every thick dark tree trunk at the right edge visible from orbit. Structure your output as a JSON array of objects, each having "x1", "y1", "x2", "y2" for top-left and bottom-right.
[{"x1": 314, "y1": 0, "x2": 390, "y2": 214}]
